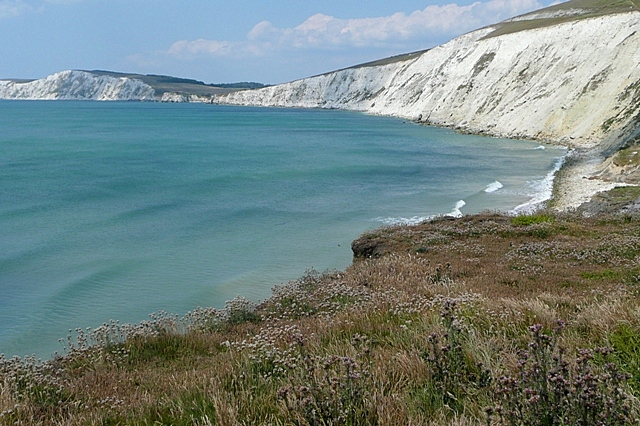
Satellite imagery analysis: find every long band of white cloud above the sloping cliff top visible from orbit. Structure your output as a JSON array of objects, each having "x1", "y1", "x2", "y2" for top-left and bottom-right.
[{"x1": 166, "y1": 0, "x2": 543, "y2": 59}]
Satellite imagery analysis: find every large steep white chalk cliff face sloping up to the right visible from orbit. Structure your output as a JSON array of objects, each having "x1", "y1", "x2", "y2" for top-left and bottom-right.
[{"x1": 218, "y1": 0, "x2": 640, "y2": 152}]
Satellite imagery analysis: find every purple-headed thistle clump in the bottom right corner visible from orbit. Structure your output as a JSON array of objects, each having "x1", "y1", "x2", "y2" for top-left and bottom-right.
[{"x1": 489, "y1": 323, "x2": 630, "y2": 426}]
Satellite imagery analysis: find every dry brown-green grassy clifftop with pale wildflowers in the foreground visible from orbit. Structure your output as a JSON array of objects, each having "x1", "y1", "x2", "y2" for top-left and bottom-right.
[{"x1": 0, "y1": 213, "x2": 640, "y2": 425}]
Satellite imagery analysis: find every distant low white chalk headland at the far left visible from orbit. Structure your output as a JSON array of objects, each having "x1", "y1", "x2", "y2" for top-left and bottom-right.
[{"x1": 0, "y1": 71, "x2": 155, "y2": 101}]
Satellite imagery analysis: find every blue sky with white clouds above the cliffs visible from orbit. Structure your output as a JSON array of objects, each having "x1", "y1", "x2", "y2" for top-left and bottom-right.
[{"x1": 0, "y1": 0, "x2": 558, "y2": 84}]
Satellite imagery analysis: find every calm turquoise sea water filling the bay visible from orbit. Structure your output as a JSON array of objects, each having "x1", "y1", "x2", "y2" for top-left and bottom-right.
[{"x1": 0, "y1": 101, "x2": 564, "y2": 358}]
